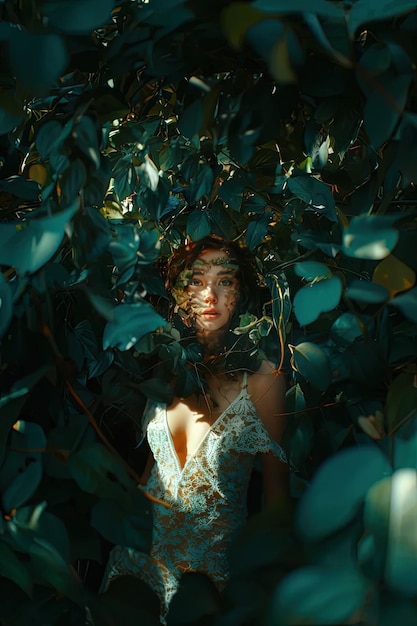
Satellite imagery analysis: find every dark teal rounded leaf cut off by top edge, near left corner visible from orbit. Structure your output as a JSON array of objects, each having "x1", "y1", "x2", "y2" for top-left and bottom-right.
[{"x1": 41, "y1": 0, "x2": 114, "y2": 34}]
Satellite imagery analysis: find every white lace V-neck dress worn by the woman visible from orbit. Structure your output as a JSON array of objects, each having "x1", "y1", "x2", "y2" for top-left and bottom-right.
[{"x1": 105, "y1": 381, "x2": 286, "y2": 614}]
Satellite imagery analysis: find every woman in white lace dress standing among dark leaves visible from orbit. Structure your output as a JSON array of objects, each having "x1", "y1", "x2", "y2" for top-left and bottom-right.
[{"x1": 105, "y1": 238, "x2": 288, "y2": 619}]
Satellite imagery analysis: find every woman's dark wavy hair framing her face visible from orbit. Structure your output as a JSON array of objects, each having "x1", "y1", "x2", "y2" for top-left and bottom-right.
[{"x1": 165, "y1": 236, "x2": 266, "y2": 374}]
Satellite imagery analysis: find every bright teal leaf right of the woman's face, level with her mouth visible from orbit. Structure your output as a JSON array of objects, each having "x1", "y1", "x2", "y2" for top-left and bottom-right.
[{"x1": 293, "y1": 276, "x2": 342, "y2": 326}]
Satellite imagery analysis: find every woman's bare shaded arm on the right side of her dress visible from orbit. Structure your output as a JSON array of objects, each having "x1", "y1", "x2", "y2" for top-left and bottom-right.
[{"x1": 248, "y1": 361, "x2": 290, "y2": 505}]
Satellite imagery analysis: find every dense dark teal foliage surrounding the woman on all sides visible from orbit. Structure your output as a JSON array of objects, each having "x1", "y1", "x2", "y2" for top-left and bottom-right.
[{"x1": 0, "y1": 0, "x2": 417, "y2": 626}]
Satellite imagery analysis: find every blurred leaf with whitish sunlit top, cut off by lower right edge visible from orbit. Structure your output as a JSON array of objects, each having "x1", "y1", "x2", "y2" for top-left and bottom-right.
[{"x1": 385, "y1": 468, "x2": 417, "y2": 597}]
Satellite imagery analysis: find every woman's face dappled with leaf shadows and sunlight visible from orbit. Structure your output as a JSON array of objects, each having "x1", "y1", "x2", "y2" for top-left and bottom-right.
[{"x1": 186, "y1": 248, "x2": 239, "y2": 333}]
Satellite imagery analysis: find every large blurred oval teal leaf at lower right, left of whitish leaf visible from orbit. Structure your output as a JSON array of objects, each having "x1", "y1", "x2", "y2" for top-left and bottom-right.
[{"x1": 296, "y1": 445, "x2": 392, "y2": 541}]
